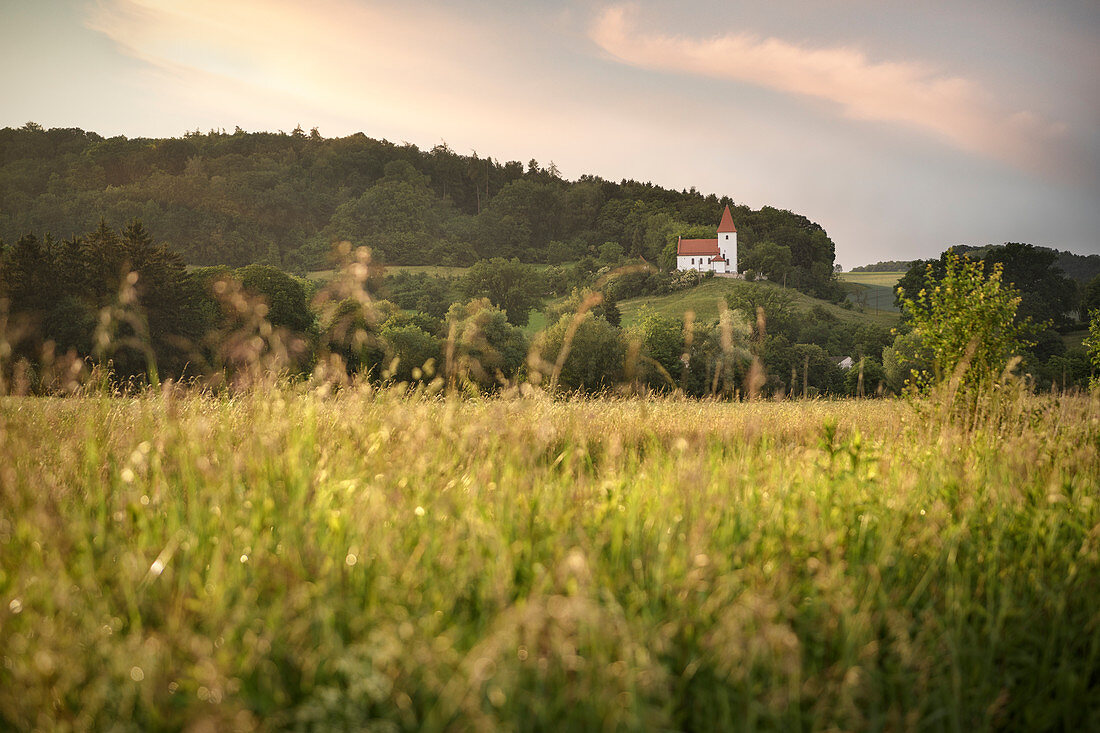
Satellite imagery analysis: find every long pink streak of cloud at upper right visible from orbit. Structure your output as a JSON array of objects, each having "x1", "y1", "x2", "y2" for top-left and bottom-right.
[{"x1": 590, "y1": 7, "x2": 1065, "y2": 171}]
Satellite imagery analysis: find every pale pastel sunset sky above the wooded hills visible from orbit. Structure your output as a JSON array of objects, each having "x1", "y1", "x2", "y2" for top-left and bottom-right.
[{"x1": 0, "y1": 0, "x2": 1100, "y2": 269}]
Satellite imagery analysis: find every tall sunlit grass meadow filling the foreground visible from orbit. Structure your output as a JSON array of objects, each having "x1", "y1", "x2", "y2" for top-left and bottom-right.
[{"x1": 0, "y1": 386, "x2": 1100, "y2": 731}]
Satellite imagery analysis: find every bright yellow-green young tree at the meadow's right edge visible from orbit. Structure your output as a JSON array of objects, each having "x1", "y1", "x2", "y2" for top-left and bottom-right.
[{"x1": 901, "y1": 250, "x2": 1034, "y2": 386}]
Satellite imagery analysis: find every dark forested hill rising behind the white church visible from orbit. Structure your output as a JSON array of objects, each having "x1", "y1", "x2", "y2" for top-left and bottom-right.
[{"x1": 0, "y1": 123, "x2": 834, "y2": 294}]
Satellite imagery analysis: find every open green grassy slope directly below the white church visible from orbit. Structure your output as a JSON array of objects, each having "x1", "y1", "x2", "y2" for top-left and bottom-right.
[{"x1": 618, "y1": 277, "x2": 898, "y2": 327}]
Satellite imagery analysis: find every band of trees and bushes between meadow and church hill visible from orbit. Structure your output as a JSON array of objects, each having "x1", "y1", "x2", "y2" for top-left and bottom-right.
[{"x1": 0, "y1": 221, "x2": 875, "y2": 396}]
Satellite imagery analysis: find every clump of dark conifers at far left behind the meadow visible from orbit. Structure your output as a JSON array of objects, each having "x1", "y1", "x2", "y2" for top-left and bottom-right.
[{"x1": 0, "y1": 221, "x2": 217, "y2": 379}]
